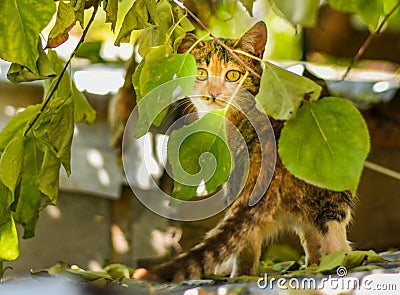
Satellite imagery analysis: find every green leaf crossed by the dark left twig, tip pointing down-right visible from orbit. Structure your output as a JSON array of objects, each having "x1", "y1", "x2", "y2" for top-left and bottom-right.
[{"x1": 44, "y1": 50, "x2": 96, "y2": 124}]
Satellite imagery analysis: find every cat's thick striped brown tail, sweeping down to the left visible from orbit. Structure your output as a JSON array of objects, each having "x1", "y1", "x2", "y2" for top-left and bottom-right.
[{"x1": 154, "y1": 183, "x2": 266, "y2": 282}]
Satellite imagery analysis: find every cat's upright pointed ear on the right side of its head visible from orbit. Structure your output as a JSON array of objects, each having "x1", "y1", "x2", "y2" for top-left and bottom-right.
[{"x1": 238, "y1": 21, "x2": 267, "y2": 58}]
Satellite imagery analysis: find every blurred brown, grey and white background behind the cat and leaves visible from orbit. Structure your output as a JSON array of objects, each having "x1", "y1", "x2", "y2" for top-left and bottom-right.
[{"x1": 0, "y1": 0, "x2": 400, "y2": 275}]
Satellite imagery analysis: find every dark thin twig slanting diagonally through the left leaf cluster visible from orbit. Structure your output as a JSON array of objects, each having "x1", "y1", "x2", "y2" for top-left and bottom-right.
[{"x1": 24, "y1": 5, "x2": 99, "y2": 136}]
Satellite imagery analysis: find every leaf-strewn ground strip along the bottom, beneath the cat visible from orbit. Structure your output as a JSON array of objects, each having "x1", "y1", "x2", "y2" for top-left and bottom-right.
[{"x1": 0, "y1": 251, "x2": 400, "y2": 295}]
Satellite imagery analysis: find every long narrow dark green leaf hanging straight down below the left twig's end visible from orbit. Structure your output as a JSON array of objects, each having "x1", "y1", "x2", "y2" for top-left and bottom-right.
[{"x1": 14, "y1": 135, "x2": 43, "y2": 239}]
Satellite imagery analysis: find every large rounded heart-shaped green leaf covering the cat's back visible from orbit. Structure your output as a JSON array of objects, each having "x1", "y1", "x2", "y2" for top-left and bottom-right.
[{"x1": 278, "y1": 97, "x2": 369, "y2": 192}]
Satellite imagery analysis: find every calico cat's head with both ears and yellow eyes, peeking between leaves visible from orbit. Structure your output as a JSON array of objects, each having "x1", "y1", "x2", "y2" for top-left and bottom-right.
[{"x1": 179, "y1": 22, "x2": 267, "y2": 112}]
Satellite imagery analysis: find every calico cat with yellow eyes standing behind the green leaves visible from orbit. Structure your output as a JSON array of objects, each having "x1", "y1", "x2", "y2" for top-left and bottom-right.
[{"x1": 141, "y1": 22, "x2": 353, "y2": 281}]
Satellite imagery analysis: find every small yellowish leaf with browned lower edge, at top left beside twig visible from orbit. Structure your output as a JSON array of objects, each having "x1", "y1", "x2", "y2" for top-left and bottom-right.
[{"x1": 46, "y1": 0, "x2": 76, "y2": 48}]
